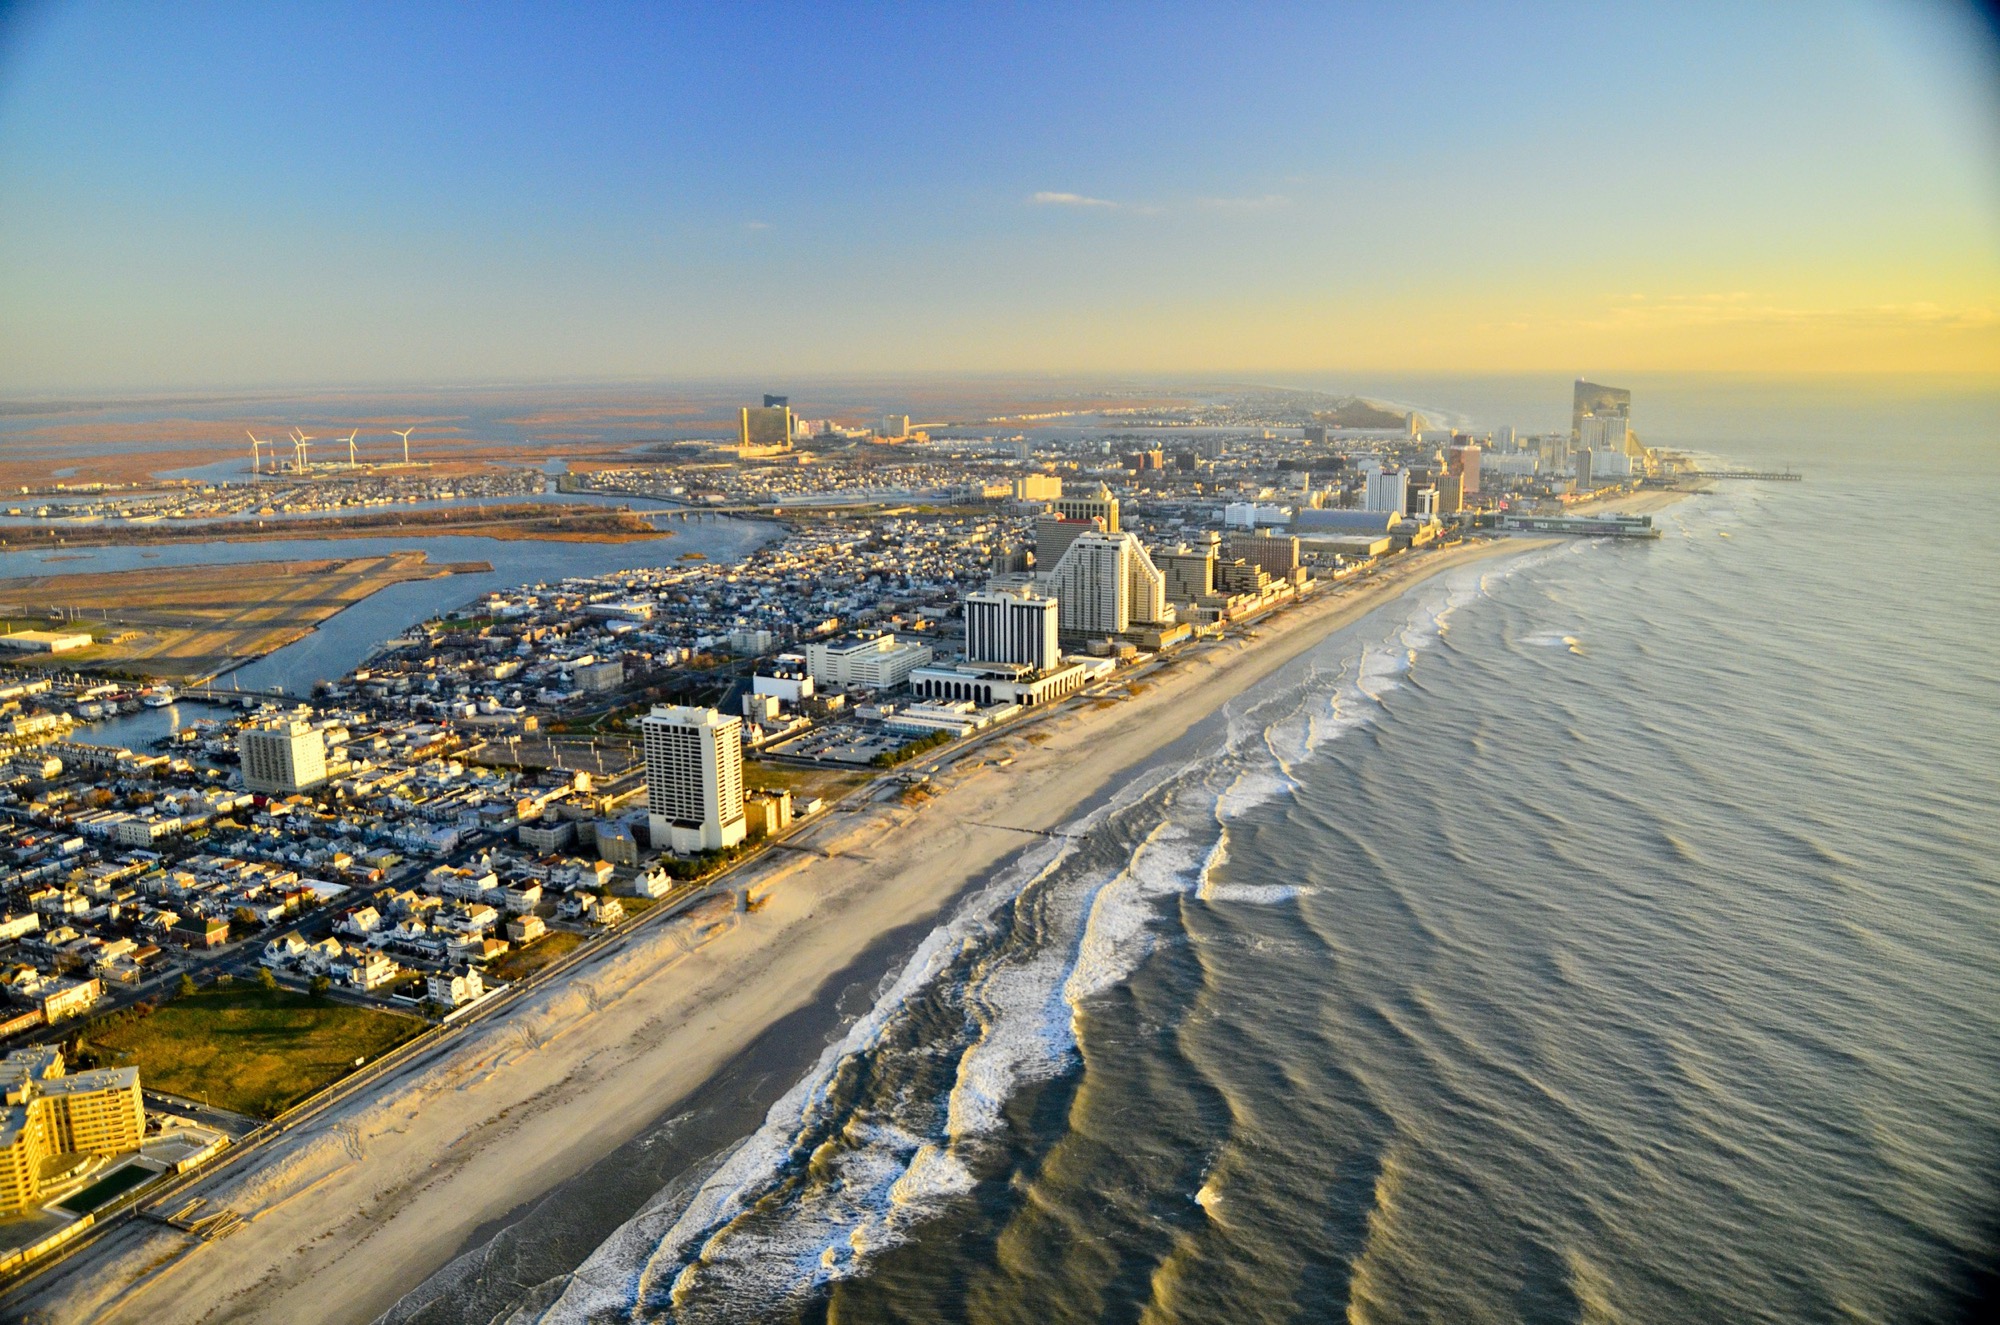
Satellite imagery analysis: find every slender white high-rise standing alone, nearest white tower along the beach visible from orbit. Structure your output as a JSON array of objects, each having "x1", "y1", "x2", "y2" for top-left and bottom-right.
[{"x1": 640, "y1": 705, "x2": 746, "y2": 855}]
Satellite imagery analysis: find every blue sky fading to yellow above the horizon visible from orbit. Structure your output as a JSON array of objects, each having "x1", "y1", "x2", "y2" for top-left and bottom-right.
[{"x1": 0, "y1": 0, "x2": 2000, "y2": 396}]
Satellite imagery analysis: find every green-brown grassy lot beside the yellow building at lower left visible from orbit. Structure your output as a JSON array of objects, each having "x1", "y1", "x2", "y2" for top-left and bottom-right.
[{"x1": 84, "y1": 983, "x2": 424, "y2": 1119}]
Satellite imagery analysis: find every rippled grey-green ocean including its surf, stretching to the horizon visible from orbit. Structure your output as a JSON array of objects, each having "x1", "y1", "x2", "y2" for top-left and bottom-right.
[{"x1": 390, "y1": 382, "x2": 2000, "y2": 1325}]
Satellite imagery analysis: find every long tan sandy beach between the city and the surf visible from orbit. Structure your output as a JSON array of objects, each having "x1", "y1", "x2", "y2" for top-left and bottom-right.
[{"x1": 10, "y1": 538, "x2": 1544, "y2": 1323}]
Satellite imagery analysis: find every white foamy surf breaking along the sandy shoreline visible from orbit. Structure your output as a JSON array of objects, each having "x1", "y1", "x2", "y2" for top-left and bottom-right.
[{"x1": 520, "y1": 556, "x2": 1512, "y2": 1321}]
